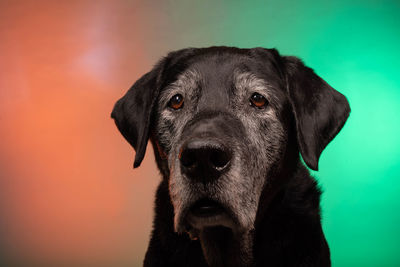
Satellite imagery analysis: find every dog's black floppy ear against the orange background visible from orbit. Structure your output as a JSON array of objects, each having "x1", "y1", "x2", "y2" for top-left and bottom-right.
[{"x1": 111, "y1": 58, "x2": 166, "y2": 168}]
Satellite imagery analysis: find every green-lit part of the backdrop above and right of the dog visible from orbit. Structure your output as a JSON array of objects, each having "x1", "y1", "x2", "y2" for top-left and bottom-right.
[{"x1": 159, "y1": 0, "x2": 400, "y2": 266}]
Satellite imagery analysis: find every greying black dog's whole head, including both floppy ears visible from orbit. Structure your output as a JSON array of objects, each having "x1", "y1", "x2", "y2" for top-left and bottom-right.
[{"x1": 112, "y1": 47, "x2": 350, "y2": 238}]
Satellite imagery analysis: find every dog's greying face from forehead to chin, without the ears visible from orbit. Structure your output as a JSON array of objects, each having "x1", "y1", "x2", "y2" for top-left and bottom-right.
[{"x1": 154, "y1": 55, "x2": 288, "y2": 234}]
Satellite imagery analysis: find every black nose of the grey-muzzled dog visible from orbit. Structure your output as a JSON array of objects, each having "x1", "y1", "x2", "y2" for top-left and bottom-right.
[{"x1": 179, "y1": 139, "x2": 232, "y2": 182}]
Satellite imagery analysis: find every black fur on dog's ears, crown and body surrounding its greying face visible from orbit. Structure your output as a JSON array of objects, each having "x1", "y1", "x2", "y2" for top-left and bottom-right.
[{"x1": 112, "y1": 47, "x2": 350, "y2": 267}]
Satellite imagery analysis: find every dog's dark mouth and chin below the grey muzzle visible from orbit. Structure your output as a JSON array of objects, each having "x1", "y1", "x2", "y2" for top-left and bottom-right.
[{"x1": 176, "y1": 198, "x2": 241, "y2": 239}]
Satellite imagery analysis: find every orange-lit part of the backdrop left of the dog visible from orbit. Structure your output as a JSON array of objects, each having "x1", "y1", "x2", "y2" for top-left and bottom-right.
[{"x1": 0, "y1": 1, "x2": 172, "y2": 266}]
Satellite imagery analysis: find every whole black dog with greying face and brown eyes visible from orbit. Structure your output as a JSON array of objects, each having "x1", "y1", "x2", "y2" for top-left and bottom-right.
[{"x1": 111, "y1": 47, "x2": 350, "y2": 267}]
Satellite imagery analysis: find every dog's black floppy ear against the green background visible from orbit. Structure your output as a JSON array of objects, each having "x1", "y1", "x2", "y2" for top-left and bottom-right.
[{"x1": 283, "y1": 57, "x2": 350, "y2": 170}]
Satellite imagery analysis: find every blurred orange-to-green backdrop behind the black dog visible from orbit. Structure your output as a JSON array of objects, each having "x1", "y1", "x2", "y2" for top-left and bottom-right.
[{"x1": 0, "y1": 0, "x2": 400, "y2": 267}]
